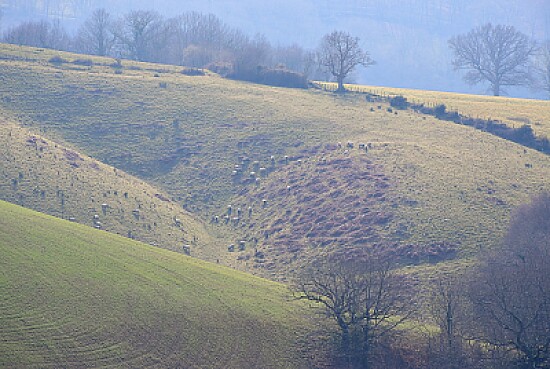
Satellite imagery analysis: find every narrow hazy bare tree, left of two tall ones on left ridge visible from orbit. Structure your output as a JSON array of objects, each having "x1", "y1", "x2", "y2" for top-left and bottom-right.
[{"x1": 76, "y1": 9, "x2": 115, "y2": 56}]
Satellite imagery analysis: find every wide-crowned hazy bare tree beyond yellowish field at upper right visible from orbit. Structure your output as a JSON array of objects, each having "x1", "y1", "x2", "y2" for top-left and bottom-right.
[{"x1": 449, "y1": 23, "x2": 536, "y2": 96}]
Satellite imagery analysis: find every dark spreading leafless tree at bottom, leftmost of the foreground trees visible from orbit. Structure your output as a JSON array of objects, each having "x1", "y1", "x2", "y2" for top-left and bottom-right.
[{"x1": 295, "y1": 253, "x2": 411, "y2": 369}]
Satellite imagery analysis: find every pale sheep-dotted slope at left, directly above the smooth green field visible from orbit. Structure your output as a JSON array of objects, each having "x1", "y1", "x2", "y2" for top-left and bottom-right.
[{"x1": 0, "y1": 118, "x2": 224, "y2": 259}]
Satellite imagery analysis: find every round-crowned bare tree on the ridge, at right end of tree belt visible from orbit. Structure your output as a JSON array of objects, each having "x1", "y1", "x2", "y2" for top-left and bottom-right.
[{"x1": 317, "y1": 31, "x2": 374, "y2": 92}]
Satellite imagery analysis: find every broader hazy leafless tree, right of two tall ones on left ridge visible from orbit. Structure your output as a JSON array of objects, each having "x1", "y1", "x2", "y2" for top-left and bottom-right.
[{"x1": 113, "y1": 10, "x2": 162, "y2": 61}]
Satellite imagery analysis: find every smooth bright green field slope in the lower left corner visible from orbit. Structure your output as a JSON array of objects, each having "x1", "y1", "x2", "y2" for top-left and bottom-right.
[{"x1": 0, "y1": 202, "x2": 314, "y2": 369}]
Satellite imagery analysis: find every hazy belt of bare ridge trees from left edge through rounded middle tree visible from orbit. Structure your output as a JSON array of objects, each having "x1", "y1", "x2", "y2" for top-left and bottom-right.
[{"x1": 3, "y1": 9, "x2": 373, "y2": 91}]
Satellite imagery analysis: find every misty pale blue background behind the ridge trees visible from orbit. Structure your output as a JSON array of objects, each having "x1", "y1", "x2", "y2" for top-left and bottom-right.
[{"x1": 0, "y1": 0, "x2": 550, "y2": 98}]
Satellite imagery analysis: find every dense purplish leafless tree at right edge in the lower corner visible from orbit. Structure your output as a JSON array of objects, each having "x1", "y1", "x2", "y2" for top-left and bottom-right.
[{"x1": 471, "y1": 193, "x2": 550, "y2": 369}]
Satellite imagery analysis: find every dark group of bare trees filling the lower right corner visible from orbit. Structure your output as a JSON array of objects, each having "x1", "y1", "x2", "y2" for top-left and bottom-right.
[{"x1": 294, "y1": 193, "x2": 550, "y2": 369}]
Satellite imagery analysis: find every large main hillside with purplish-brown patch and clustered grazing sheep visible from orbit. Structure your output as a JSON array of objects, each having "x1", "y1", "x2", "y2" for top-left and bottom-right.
[{"x1": 0, "y1": 46, "x2": 550, "y2": 273}]
